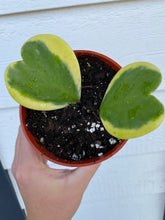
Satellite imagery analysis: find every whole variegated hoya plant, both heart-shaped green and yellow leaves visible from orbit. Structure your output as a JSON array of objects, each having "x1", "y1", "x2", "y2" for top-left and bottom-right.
[{"x1": 5, "y1": 34, "x2": 164, "y2": 165}]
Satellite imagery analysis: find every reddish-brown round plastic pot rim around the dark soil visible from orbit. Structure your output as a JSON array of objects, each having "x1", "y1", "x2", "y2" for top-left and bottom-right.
[{"x1": 20, "y1": 50, "x2": 127, "y2": 167}]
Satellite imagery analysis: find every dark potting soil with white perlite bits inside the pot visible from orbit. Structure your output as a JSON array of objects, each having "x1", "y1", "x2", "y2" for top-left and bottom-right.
[{"x1": 26, "y1": 56, "x2": 121, "y2": 161}]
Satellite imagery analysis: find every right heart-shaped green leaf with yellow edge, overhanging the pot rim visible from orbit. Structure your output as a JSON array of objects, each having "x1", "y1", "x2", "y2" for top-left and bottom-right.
[{"x1": 100, "y1": 62, "x2": 164, "y2": 139}]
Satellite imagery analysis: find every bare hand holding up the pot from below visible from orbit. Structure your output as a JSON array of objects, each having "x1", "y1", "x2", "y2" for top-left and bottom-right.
[{"x1": 12, "y1": 128, "x2": 99, "y2": 220}]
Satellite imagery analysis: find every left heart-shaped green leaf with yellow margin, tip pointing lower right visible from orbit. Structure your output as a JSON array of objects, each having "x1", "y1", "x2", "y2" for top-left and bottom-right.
[{"x1": 5, "y1": 34, "x2": 81, "y2": 110}]
